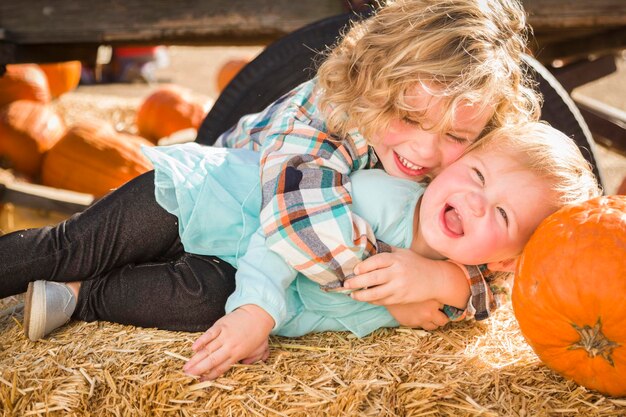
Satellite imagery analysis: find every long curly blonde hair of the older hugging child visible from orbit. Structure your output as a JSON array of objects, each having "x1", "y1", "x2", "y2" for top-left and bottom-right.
[{"x1": 318, "y1": 0, "x2": 541, "y2": 140}]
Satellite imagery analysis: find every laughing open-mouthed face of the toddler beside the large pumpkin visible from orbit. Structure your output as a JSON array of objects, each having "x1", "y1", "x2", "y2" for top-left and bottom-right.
[{"x1": 416, "y1": 149, "x2": 555, "y2": 265}]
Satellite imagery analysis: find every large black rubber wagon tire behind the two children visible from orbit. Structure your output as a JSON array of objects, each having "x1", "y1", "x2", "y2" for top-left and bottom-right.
[{"x1": 196, "y1": 13, "x2": 602, "y2": 183}]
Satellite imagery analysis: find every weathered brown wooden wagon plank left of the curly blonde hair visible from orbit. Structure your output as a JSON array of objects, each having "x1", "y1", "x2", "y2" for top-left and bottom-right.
[{"x1": 0, "y1": 0, "x2": 344, "y2": 44}]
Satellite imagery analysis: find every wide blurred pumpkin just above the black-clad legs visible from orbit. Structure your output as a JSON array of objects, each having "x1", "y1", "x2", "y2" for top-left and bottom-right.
[{"x1": 41, "y1": 121, "x2": 152, "y2": 196}]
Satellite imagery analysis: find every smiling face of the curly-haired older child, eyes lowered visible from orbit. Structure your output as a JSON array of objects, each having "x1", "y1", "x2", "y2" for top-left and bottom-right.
[{"x1": 373, "y1": 86, "x2": 493, "y2": 181}]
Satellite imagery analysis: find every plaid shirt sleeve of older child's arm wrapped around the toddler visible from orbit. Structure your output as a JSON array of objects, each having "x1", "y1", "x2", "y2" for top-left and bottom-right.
[{"x1": 261, "y1": 120, "x2": 378, "y2": 287}]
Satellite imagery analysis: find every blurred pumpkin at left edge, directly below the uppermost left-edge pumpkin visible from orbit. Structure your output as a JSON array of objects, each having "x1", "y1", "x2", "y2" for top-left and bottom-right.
[{"x1": 0, "y1": 100, "x2": 65, "y2": 179}]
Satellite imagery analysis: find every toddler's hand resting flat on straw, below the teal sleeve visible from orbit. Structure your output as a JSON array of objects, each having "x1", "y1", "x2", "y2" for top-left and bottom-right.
[{"x1": 183, "y1": 304, "x2": 274, "y2": 380}]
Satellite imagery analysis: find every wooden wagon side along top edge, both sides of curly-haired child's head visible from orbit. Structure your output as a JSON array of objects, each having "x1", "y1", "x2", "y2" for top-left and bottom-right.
[{"x1": 0, "y1": 0, "x2": 626, "y2": 65}]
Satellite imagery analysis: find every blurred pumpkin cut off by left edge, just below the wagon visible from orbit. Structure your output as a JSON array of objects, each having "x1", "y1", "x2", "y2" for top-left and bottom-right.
[{"x1": 0, "y1": 64, "x2": 51, "y2": 107}]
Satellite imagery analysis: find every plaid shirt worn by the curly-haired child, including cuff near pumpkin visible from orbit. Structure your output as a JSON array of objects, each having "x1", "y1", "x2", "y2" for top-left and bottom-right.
[{"x1": 216, "y1": 79, "x2": 497, "y2": 319}]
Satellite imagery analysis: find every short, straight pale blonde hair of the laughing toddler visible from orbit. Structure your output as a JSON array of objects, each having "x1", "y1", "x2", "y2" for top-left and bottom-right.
[{"x1": 465, "y1": 122, "x2": 602, "y2": 210}]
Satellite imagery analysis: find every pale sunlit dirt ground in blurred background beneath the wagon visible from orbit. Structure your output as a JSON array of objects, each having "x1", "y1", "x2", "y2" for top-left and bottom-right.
[{"x1": 80, "y1": 46, "x2": 626, "y2": 194}]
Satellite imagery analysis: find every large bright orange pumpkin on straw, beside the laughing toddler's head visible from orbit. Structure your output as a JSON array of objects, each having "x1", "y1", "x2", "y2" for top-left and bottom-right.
[{"x1": 512, "y1": 195, "x2": 626, "y2": 396}]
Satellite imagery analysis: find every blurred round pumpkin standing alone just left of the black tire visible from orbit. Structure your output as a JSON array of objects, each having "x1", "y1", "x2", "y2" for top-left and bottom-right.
[{"x1": 136, "y1": 85, "x2": 208, "y2": 143}]
